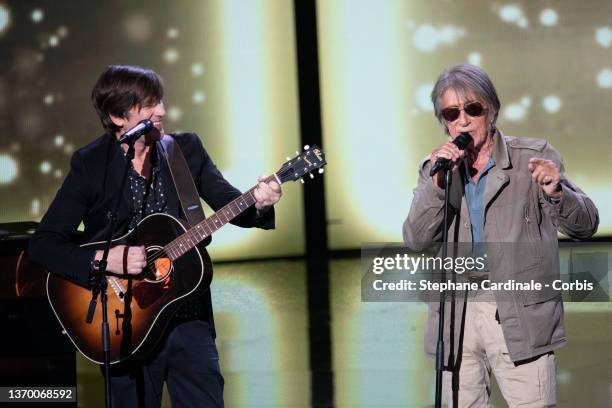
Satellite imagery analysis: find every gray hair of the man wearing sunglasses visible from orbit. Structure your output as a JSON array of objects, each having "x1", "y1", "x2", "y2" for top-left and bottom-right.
[{"x1": 431, "y1": 64, "x2": 501, "y2": 125}]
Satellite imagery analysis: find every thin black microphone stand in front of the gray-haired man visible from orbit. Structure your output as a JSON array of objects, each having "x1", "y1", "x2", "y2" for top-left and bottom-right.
[{"x1": 435, "y1": 162, "x2": 452, "y2": 408}]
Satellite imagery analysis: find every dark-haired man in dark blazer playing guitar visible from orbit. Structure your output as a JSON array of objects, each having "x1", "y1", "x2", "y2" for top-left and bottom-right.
[{"x1": 29, "y1": 65, "x2": 282, "y2": 407}]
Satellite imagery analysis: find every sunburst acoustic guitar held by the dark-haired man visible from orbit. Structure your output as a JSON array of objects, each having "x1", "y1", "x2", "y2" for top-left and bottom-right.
[{"x1": 47, "y1": 146, "x2": 327, "y2": 364}]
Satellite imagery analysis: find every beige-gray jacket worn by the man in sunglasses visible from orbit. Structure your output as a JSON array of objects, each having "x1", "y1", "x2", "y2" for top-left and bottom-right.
[{"x1": 403, "y1": 132, "x2": 599, "y2": 363}]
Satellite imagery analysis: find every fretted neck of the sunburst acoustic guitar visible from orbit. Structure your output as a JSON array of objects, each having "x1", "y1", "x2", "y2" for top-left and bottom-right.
[{"x1": 164, "y1": 174, "x2": 280, "y2": 260}]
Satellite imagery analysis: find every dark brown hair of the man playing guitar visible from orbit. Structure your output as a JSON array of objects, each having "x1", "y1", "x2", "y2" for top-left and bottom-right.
[{"x1": 91, "y1": 65, "x2": 164, "y2": 132}]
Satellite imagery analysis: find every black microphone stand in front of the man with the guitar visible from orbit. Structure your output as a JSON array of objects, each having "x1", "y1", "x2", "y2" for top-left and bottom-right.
[{"x1": 85, "y1": 135, "x2": 136, "y2": 408}]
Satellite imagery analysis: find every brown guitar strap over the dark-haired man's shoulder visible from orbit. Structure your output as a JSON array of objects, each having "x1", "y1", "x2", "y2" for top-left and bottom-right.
[{"x1": 160, "y1": 135, "x2": 206, "y2": 227}]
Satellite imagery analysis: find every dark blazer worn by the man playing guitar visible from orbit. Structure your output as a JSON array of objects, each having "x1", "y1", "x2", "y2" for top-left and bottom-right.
[{"x1": 29, "y1": 133, "x2": 274, "y2": 287}]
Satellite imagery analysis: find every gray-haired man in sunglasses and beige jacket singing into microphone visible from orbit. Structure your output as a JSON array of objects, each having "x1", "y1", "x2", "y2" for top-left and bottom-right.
[{"x1": 403, "y1": 65, "x2": 599, "y2": 407}]
